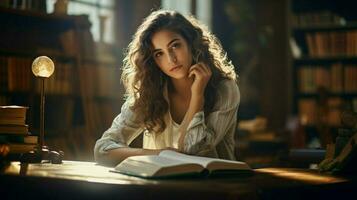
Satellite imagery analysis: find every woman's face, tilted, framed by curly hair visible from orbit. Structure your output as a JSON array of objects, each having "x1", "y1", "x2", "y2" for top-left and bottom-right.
[{"x1": 151, "y1": 30, "x2": 192, "y2": 79}]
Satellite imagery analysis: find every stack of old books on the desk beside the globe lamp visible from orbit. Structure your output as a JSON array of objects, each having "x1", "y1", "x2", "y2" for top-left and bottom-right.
[{"x1": 0, "y1": 106, "x2": 38, "y2": 154}]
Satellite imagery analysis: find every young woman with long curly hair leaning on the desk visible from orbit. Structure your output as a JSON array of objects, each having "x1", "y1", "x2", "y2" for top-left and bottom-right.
[{"x1": 94, "y1": 10, "x2": 240, "y2": 164}]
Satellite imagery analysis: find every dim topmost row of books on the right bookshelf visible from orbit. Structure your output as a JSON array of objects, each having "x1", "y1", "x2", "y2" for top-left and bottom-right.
[{"x1": 292, "y1": 10, "x2": 346, "y2": 27}]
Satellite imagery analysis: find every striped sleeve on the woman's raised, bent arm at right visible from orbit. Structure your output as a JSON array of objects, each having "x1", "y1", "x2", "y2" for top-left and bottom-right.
[{"x1": 184, "y1": 80, "x2": 240, "y2": 155}]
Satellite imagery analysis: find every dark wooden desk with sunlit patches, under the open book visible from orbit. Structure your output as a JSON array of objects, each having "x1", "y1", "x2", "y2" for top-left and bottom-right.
[{"x1": 0, "y1": 161, "x2": 355, "y2": 200}]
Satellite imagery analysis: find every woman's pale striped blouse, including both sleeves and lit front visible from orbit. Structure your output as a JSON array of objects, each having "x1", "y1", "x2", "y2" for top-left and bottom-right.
[{"x1": 94, "y1": 80, "x2": 240, "y2": 160}]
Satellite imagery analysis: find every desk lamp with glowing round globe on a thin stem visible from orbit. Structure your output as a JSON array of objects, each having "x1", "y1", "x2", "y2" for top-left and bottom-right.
[{"x1": 21, "y1": 56, "x2": 63, "y2": 164}]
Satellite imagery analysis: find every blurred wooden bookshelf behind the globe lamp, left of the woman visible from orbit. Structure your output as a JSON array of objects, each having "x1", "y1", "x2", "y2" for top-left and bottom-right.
[{"x1": 0, "y1": 7, "x2": 122, "y2": 160}]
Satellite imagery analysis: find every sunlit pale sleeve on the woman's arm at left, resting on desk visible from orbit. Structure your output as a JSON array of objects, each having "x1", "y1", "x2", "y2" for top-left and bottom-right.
[{"x1": 94, "y1": 100, "x2": 143, "y2": 160}]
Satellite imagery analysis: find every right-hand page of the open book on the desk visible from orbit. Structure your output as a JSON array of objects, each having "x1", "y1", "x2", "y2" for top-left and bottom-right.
[{"x1": 159, "y1": 150, "x2": 241, "y2": 168}]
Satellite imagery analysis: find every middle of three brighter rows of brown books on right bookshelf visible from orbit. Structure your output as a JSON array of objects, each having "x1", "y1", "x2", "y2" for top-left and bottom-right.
[{"x1": 298, "y1": 63, "x2": 357, "y2": 93}]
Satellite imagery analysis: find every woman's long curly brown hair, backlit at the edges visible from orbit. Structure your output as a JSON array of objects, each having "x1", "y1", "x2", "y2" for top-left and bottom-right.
[{"x1": 121, "y1": 10, "x2": 236, "y2": 133}]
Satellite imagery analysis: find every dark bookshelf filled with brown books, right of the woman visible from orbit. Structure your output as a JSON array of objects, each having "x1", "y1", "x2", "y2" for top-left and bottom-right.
[{"x1": 287, "y1": 0, "x2": 357, "y2": 147}]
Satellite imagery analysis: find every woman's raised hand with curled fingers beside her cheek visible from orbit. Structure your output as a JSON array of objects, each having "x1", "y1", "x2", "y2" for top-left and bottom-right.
[{"x1": 188, "y1": 62, "x2": 212, "y2": 96}]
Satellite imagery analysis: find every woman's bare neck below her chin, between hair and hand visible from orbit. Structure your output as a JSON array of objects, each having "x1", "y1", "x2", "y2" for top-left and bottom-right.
[{"x1": 170, "y1": 78, "x2": 193, "y2": 99}]
